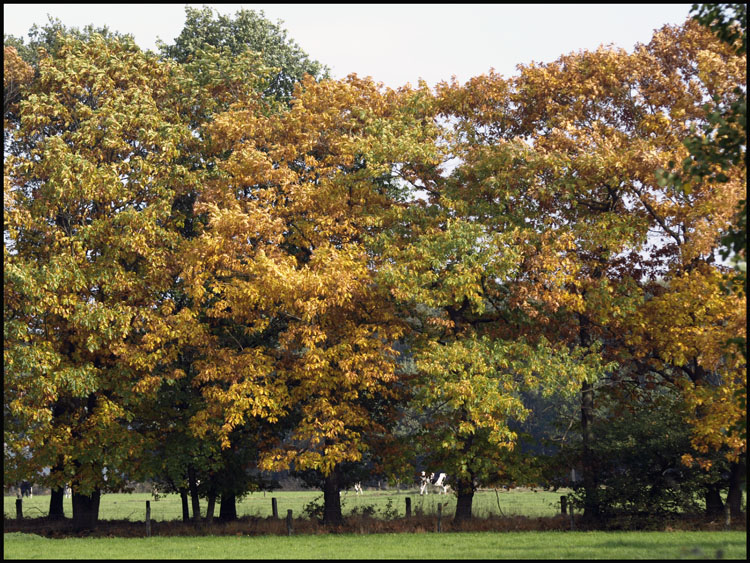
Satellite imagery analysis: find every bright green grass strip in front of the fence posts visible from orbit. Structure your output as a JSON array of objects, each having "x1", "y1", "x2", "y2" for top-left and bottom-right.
[{"x1": 3, "y1": 531, "x2": 747, "y2": 560}]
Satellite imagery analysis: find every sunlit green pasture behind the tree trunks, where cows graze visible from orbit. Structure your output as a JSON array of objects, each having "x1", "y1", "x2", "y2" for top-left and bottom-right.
[{"x1": 4, "y1": 489, "x2": 565, "y2": 521}]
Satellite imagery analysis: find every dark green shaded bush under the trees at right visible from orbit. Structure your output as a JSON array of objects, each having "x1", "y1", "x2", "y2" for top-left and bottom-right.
[{"x1": 564, "y1": 392, "x2": 726, "y2": 526}]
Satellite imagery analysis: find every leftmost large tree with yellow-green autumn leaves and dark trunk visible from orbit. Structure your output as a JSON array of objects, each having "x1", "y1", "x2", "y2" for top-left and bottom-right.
[{"x1": 4, "y1": 35, "x2": 197, "y2": 528}]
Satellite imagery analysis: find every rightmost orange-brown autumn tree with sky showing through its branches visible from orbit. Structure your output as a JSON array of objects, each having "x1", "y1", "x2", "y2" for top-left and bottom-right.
[{"x1": 508, "y1": 17, "x2": 745, "y2": 517}]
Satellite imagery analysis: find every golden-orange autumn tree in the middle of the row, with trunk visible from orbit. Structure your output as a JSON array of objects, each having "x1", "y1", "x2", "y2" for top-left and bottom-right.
[{"x1": 185, "y1": 72, "x2": 438, "y2": 523}]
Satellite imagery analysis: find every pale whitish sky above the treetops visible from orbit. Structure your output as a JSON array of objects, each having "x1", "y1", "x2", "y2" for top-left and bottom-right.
[{"x1": 3, "y1": 4, "x2": 692, "y2": 88}]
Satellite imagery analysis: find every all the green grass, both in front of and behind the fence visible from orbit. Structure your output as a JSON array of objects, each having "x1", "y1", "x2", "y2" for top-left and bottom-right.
[{"x1": 3, "y1": 489, "x2": 747, "y2": 560}]
